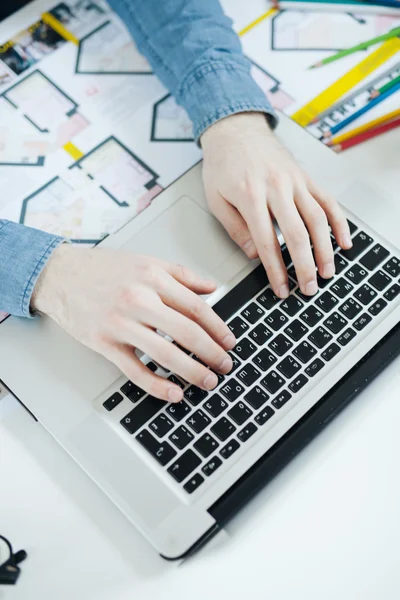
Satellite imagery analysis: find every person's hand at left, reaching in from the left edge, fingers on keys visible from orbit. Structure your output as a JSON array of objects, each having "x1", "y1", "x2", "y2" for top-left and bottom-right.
[{"x1": 31, "y1": 244, "x2": 236, "y2": 402}]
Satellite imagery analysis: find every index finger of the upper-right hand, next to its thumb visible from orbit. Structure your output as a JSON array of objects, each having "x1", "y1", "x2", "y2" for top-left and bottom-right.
[{"x1": 239, "y1": 190, "x2": 289, "y2": 298}]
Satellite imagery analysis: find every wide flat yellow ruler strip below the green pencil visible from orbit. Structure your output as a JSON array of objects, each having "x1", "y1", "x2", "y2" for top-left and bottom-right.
[{"x1": 292, "y1": 37, "x2": 400, "y2": 127}]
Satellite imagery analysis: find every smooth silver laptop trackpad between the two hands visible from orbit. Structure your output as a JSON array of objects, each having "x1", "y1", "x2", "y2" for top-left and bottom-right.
[{"x1": 124, "y1": 196, "x2": 241, "y2": 277}]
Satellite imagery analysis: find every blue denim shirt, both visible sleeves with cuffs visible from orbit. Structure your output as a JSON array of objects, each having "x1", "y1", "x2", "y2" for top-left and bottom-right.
[{"x1": 0, "y1": 0, "x2": 276, "y2": 317}]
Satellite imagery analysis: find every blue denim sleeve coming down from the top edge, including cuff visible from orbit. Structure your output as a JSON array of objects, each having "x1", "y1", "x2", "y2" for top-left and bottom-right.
[{"x1": 109, "y1": 0, "x2": 276, "y2": 140}]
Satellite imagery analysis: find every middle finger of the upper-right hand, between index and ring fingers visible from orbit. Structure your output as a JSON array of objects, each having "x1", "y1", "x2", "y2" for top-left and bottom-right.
[{"x1": 270, "y1": 180, "x2": 318, "y2": 296}]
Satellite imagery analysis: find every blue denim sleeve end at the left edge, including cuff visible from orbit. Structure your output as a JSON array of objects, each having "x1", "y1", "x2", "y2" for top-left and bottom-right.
[{"x1": 0, "y1": 220, "x2": 64, "y2": 317}]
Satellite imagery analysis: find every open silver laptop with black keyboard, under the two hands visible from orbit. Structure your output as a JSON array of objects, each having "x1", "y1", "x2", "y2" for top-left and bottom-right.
[{"x1": 0, "y1": 117, "x2": 400, "y2": 559}]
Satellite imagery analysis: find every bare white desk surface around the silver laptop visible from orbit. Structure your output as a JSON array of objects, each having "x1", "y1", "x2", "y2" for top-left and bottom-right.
[{"x1": 0, "y1": 2, "x2": 400, "y2": 600}]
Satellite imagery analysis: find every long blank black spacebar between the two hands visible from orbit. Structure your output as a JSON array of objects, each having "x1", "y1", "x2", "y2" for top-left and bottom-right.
[{"x1": 213, "y1": 264, "x2": 268, "y2": 321}]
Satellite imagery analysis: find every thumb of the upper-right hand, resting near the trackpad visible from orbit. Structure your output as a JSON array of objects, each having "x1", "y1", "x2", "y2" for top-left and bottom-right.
[{"x1": 209, "y1": 194, "x2": 258, "y2": 259}]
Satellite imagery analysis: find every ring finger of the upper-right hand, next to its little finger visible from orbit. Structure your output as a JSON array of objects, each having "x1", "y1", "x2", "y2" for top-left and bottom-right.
[{"x1": 295, "y1": 185, "x2": 335, "y2": 279}]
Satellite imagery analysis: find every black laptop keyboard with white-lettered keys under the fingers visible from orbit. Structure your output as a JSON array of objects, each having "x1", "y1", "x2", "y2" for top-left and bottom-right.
[{"x1": 103, "y1": 222, "x2": 400, "y2": 494}]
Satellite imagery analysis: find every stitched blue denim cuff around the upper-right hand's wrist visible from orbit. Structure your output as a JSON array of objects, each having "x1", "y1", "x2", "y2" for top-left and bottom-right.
[{"x1": 176, "y1": 61, "x2": 278, "y2": 141}]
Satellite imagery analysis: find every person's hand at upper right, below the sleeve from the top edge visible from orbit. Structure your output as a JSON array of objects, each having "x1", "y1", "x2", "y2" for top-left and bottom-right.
[{"x1": 201, "y1": 113, "x2": 352, "y2": 298}]
